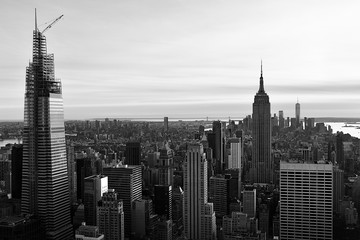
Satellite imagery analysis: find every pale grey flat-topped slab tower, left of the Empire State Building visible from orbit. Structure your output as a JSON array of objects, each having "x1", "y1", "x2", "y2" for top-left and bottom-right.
[{"x1": 228, "y1": 138, "x2": 242, "y2": 199}]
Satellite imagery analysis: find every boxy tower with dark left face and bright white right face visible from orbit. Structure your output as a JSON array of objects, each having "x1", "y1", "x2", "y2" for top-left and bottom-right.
[{"x1": 84, "y1": 175, "x2": 108, "y2": 226}]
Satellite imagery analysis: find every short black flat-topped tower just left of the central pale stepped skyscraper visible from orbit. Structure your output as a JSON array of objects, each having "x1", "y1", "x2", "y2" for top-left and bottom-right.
[{"x1": 154, "y1": 185, "x2": 172, "y2": 220}]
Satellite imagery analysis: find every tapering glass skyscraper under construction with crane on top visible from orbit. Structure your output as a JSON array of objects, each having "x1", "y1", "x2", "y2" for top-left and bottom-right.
[{"x1": 21, "y1": 13, "x2": 73, "y2": 239}]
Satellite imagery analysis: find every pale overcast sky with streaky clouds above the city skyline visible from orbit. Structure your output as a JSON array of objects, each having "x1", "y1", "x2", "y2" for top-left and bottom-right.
[{"x1": 0, "y1": 0, "x2": 360, "y2": 120}]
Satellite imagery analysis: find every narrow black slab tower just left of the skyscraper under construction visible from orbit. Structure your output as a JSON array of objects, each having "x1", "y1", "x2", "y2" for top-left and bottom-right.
[{"x1": 11, "y1": 144, "x2": 23, "y2": 199}]
